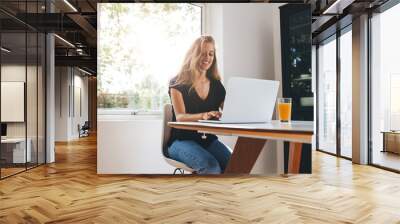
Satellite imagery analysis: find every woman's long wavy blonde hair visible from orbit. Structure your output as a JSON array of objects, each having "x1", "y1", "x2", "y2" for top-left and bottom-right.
[{"x1": 174, "y1": 36, "x2": 221, "y2": 87}]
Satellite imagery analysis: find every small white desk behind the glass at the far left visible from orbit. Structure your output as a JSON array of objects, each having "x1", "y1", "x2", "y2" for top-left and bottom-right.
[{"x1": 1, "y1": 138, "x2": 32, "y2": 163}]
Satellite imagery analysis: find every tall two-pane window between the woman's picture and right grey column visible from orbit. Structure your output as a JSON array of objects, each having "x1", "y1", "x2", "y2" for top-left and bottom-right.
[{"x1": 317, "y1": 24, "x2": 353, "y2": 159}]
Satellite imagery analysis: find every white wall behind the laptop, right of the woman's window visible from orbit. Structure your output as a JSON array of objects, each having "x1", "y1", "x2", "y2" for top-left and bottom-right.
[{"x1": 205, "y1": 3, "x2": 283, "y2": 174}]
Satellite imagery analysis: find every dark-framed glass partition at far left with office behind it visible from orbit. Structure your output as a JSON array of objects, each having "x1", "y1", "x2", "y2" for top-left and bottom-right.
[{"x1": 0, "y1": 1, "x2": 46, "y2": 179}]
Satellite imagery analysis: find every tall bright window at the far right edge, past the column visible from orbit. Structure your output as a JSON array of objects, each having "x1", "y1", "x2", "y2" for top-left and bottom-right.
[{"x1": 370, "y1": 4, "x2": 400, "y2": 170}]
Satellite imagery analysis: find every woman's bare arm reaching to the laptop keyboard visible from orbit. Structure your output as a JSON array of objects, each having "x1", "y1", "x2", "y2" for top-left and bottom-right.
[{"x1": 170, "y1": 88, "x2": 219, "y2": 121}]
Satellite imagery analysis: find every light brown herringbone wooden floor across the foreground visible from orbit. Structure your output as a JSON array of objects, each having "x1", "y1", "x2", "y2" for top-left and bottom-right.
[{"x1": 0, "y1": 134, "x2": 400, "y2": 224}]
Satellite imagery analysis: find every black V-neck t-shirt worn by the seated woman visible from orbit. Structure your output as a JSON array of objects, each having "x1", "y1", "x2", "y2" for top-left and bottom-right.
[{"x1": 168, "y1": 77, "x2": 226, "y2": 147}]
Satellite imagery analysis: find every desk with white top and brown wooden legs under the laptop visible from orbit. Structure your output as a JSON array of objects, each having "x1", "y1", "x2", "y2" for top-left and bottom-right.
[{"x1": 168, "y1": 121, "x2": 314, "y2": 174}]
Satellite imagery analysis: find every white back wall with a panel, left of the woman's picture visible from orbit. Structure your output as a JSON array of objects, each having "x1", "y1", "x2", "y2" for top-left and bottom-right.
[{"x1": 55, "y1": 67, "x2": 88, "y2": 141}]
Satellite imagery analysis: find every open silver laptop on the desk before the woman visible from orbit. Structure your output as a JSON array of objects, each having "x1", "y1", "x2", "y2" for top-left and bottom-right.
[{"x1": 199, "y1": 77, "x2": 279, "y2": 124}]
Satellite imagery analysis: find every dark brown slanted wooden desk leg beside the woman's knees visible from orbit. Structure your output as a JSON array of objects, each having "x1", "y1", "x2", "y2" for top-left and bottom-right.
[{"x1": 224, "y1": 137, "x2": 267, "y2": 174}]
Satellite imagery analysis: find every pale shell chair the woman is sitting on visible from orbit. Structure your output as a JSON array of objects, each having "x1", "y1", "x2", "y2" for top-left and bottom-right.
[{"x1": 161, "y1": 104, "x2": 195, "y2": 174}]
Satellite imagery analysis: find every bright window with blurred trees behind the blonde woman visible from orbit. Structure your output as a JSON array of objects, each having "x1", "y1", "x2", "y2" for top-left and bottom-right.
[{"x1": 98, "y1": 3, "x2": 202, "y2": 112}]
